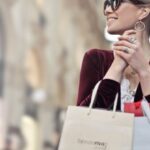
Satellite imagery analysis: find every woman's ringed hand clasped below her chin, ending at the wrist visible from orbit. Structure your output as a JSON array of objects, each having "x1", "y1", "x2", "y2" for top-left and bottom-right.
[{"x1": 114, "y1": 30, "x2": 149, "y2": 76}]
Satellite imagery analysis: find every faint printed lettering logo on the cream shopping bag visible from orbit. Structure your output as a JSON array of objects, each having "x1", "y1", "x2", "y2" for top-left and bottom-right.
[{"x1": 77, "y1": 138, "x2": 108, "y2": 150}]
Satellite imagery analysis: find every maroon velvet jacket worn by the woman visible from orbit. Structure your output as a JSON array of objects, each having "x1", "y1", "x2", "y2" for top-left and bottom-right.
[{"x1": 77, "y1": 49, "x2": 150, "y2": 110}]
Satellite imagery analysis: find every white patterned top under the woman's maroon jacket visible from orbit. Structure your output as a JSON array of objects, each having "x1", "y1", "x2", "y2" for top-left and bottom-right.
[{"x1": 121, "y1": 78, "x2": 136, "y2": 111}]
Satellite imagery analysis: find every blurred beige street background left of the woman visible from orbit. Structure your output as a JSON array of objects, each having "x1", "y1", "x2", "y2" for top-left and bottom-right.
[{"x1": 0, "y1": 0, "x2": 114, "y2": 150}]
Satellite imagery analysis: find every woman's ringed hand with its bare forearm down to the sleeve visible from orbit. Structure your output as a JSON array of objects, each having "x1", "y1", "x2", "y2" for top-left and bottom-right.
[{"x1": 114, "y1": 29, "x2": 150, "y2": 96}]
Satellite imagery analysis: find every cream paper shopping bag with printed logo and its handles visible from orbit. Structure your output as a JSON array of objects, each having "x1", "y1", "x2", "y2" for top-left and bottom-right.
[{"x1": 58, "y1": 83, "x2": 134, "y2": 150}]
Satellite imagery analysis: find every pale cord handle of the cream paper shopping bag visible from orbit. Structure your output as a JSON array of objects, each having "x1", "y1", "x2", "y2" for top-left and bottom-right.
[{"x1": 88, "y1": 80, "x2": 118, "y2": 117}]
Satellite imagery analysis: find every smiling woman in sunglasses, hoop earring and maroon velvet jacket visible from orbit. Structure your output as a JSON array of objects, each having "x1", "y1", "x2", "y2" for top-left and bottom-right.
[{"x1": 77, "y1": 0, "x2": 150, "y2": 111}]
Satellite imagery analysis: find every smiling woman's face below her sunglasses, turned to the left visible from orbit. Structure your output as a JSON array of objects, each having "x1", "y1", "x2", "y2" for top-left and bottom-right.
[{"x1": 104, "y1": 1, "x2": 140, "y2": 34}]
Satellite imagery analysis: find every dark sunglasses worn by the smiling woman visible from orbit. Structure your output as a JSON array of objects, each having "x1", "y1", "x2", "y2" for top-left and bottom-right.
[{"x1": 104, "y1": 0, "x2": 145, "y2": 11}]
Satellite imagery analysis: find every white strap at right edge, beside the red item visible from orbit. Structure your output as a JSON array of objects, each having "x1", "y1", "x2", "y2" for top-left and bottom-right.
[{"x1": 141, "y1": 97, "x2": 150, "y2": 122}]
